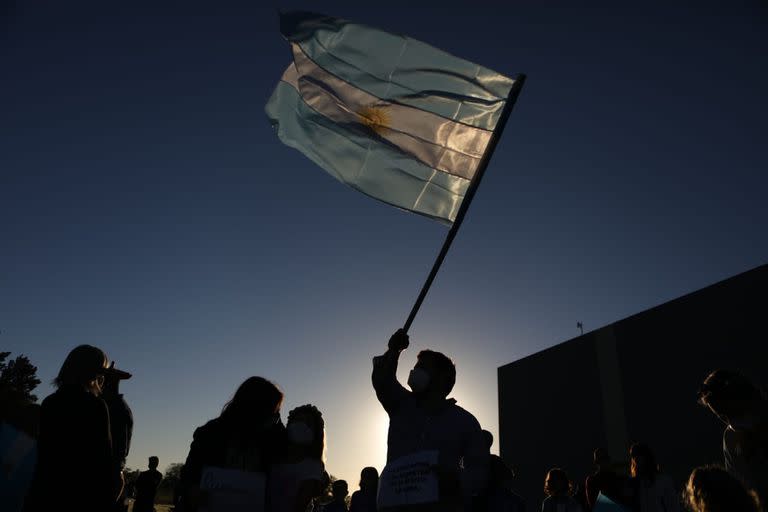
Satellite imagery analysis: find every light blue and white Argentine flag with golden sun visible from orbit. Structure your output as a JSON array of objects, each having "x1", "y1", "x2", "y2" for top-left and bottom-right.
[{"x1": 266, "y1": 12, "x2": 514, "y2": 223}]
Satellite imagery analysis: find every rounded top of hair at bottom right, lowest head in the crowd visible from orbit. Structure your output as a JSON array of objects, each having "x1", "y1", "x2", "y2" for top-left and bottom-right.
[{"x1": 684, "y1": 466, "x2": 759, "y2": 512}]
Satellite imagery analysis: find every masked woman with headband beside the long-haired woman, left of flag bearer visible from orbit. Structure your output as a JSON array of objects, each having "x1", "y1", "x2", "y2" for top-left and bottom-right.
[{"x1": 267, "y1": 404, "x2": 325, "y2": 512}]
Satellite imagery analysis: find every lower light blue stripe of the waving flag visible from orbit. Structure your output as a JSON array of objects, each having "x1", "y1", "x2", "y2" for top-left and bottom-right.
[{"x1": 266, "y1": 82, "x2": 469, "y2": 221}]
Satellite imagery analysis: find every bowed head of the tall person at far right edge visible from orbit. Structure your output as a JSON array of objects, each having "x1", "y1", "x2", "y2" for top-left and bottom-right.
[{"x1": 698, "y1": 370, "x2": 763, "y2": 430}]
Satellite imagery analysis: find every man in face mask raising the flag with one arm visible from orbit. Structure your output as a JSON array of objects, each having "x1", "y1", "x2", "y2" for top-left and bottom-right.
[{"x1": 372, "y1": 329, "x2": 488, "y2": 512}]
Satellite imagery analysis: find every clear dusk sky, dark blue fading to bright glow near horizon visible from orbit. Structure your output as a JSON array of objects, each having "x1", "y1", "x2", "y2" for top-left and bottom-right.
[{"x1": 0, "y1": 0, "x2": 768, "y2": 490}]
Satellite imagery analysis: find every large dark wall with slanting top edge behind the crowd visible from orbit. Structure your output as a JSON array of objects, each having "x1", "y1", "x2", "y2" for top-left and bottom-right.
[{"x1": 498, "y1": 265, "x2": 768, "y2": 510}]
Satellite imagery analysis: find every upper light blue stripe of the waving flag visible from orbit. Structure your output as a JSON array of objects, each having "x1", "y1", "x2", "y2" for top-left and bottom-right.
[{"x1": 280, "y1": 12, "x2": 514, "y2": 130}]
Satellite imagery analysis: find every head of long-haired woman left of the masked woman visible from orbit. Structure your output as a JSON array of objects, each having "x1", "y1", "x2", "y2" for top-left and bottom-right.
[{"x1": 219, "y1": 377, "x2": 283, "y2": 430}]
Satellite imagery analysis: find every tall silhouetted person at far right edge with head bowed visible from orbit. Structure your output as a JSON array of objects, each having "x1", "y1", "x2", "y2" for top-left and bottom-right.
[{"x1": 699, "y1": 370, "x2": 768, "y2": 504}]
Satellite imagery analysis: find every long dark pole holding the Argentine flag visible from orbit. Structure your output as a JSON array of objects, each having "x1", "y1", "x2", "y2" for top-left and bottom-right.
[{"x1": 403, "y1": 74, "x2": 525, "y2": 332}]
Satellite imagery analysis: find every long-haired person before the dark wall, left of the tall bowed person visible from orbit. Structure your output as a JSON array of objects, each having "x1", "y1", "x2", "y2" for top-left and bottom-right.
[{"x1": 629, "y1": 443, "x2": 680, "y2": 512}]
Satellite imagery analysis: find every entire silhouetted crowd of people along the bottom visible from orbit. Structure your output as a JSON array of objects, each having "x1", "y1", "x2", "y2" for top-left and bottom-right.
[{"x1": 0, "y1": 330, "x2": 768, "y2": 512}]
